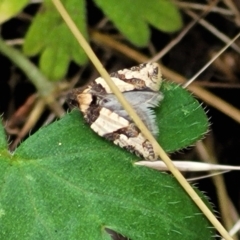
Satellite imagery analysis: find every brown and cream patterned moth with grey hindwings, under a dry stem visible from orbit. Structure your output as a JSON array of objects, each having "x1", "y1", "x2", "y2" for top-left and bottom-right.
[{"x1": 68, "y1": 63, "x2": 163, "y2": 161}]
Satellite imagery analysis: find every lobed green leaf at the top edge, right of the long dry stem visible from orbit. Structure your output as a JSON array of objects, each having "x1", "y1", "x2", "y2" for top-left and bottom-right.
[{"x1": 94, "y1": 0, "x2": 182, "y2": 47}]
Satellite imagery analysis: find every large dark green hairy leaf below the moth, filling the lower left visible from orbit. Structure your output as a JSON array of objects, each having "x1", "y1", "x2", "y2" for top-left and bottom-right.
[{"x1": 0, "y1": 83, "x2": 214, "y2": 240}]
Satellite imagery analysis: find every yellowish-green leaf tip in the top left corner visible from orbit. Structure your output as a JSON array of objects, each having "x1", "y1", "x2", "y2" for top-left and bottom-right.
[{"x1": 0, "y1": 0, "x2": 29, "y2": 23}]
